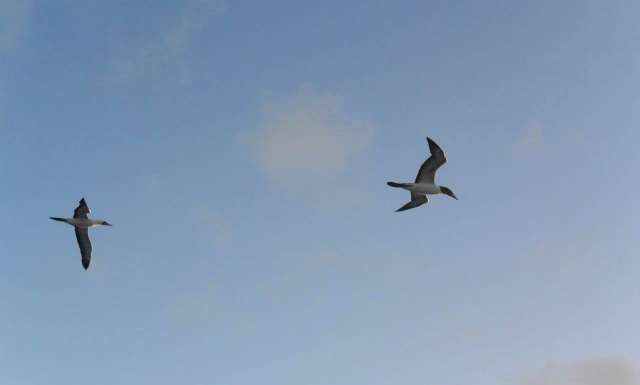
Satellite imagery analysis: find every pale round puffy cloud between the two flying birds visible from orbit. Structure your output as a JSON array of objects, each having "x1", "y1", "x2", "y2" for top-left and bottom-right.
[{"x1": 249, "y1": 89, "x2": 373, "y2": 200}]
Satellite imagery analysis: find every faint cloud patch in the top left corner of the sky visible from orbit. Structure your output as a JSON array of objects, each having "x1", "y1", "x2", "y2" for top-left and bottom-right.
[{"x1": 0, "y1": 0, "x2": 29, "y2": 52}]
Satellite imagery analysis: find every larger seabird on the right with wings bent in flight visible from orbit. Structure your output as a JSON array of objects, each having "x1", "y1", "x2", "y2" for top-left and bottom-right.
[{"x1": 387, "y1": 138, "x2": 458, "y2": 212}]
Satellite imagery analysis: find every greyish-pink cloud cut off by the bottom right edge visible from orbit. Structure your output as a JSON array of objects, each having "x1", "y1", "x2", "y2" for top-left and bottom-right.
[{"x1": 523, "y1": 359, "x2": 640, "y2": 385}]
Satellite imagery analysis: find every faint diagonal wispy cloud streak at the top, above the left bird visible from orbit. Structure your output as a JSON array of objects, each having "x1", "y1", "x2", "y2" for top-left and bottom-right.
[{"x1": 112, "y1": 0, "x2": 226, "y2": 82}]
